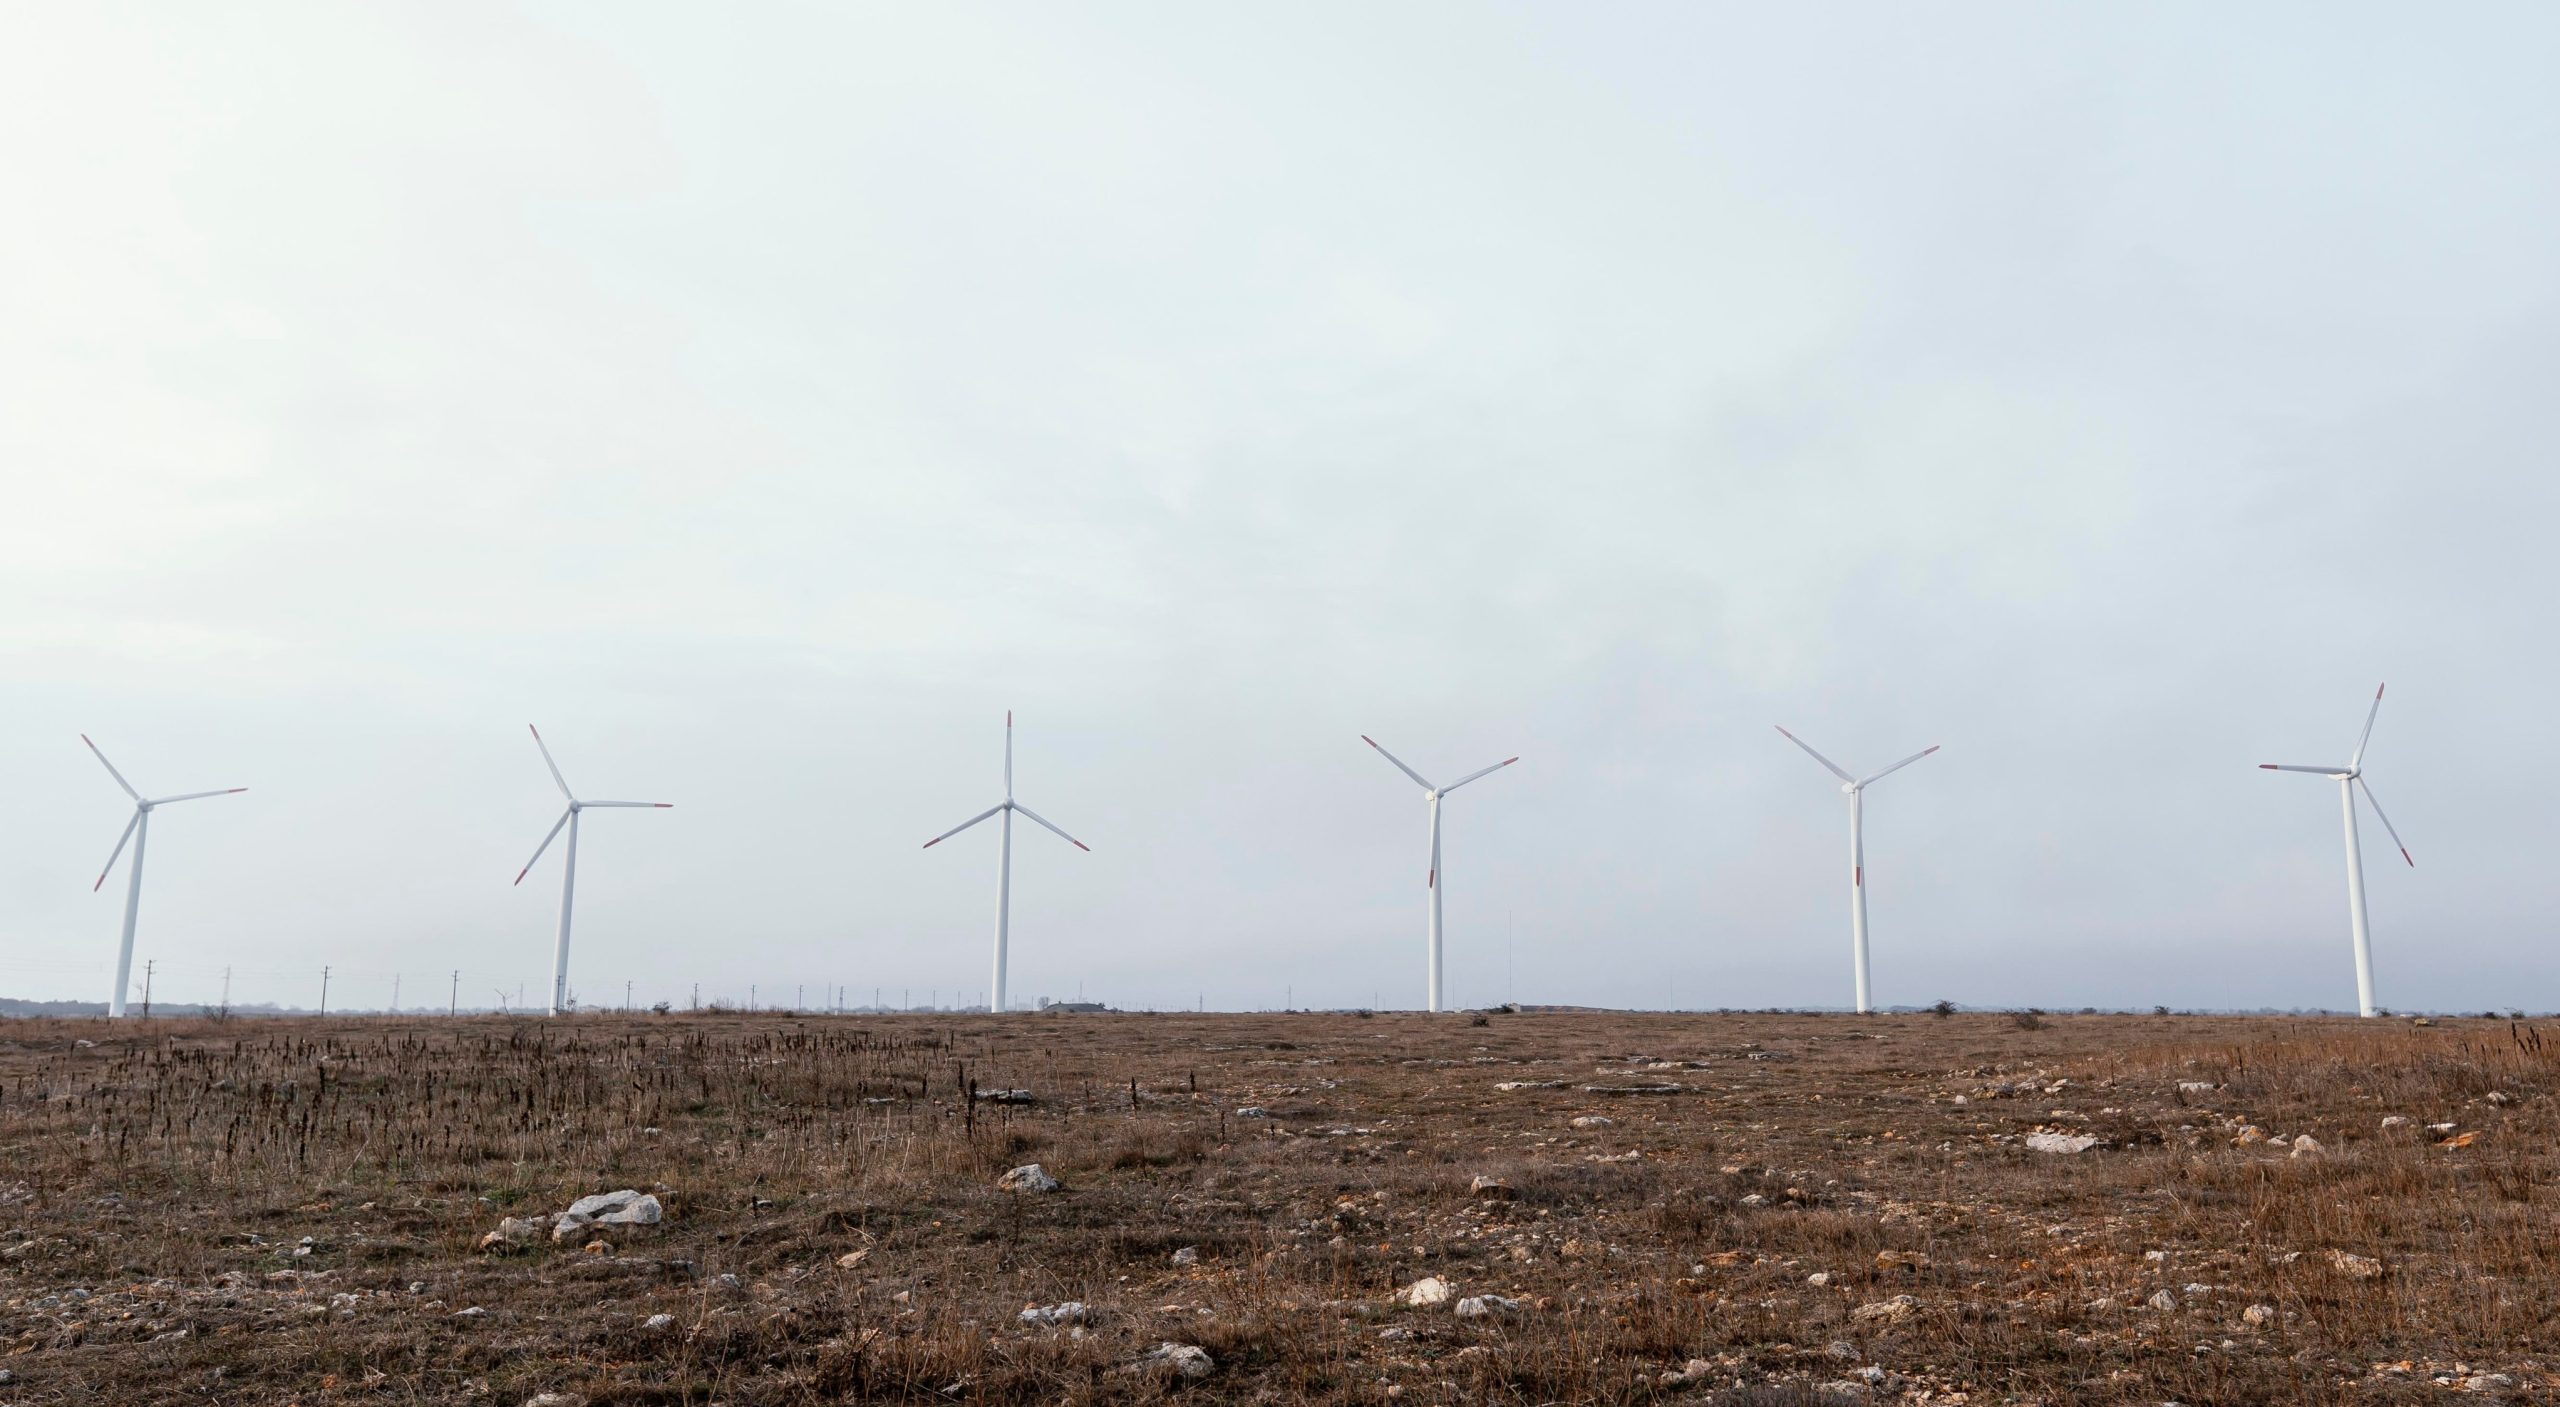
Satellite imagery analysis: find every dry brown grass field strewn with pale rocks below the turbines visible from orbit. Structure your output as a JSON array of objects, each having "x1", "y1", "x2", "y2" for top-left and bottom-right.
[{"x1": 0, "y1": 1013, "x2": 2560, "y2": 1407}]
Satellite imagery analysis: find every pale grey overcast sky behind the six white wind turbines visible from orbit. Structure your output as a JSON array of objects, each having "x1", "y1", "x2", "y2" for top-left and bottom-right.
[{"x1": 0, "y1": 3, "x2": 2560, "y2": 1008}]
